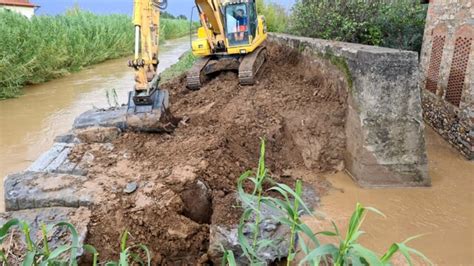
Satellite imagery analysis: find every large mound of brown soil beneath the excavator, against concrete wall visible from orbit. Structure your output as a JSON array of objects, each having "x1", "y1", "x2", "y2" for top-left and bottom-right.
[{"x1": 73, "y1": 44, "x2": 347, "y2": 265}]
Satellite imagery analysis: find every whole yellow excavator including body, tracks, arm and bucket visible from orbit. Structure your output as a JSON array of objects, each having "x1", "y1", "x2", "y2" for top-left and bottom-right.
[{"x1": 127, "y1": 0, "x2": 267, "y2": 132}]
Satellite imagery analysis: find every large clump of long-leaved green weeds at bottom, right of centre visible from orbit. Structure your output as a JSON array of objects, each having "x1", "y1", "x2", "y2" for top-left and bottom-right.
[{"x1": 222, "y1": 140, "x2": 432, "y2": 266}]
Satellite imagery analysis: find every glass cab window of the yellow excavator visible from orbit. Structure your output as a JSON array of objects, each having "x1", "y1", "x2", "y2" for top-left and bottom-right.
[{"x1": 225, "y1": 3, "x2": 251, "y2": 46}]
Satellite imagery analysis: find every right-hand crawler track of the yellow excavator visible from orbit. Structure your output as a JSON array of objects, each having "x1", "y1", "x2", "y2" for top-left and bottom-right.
[{"x1": 239, "y1": 46, "x2": 267, "y2": 85}]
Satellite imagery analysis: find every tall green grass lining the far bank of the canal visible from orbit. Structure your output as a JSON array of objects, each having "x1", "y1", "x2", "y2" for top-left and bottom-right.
[{"x1": 0, "y1": 9, "x2": 193, "y2": 99}]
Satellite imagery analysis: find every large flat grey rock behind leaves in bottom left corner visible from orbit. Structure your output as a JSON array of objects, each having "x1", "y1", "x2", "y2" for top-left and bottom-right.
[{"x1": 0, "y1": 208, "x2": 91, "y2": 265}]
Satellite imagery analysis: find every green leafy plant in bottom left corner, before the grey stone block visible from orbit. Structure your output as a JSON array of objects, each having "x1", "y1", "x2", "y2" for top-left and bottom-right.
[{"x1": 0, "y1": 219, "x2": 79, "y2": 266}]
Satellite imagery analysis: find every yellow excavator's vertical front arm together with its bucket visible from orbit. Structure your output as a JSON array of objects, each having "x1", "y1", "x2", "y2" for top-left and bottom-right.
[{"x1": 126, "y1": 0, "x2": 178, "y2": 133}]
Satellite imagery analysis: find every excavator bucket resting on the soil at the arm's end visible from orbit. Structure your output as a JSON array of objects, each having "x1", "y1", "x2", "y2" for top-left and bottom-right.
[{"x1": 126, "y1": 89, "x2": 180, "y2": 133}]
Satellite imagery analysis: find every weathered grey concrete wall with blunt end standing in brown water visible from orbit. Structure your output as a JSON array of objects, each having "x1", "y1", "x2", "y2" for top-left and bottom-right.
[{"x1": 270, "y1": 34, "x2": 431, "y2": 187}]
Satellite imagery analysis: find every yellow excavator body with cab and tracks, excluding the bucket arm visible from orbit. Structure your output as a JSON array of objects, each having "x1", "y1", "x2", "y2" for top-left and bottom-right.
[{"x1": 187, "y1": 0, "x2": 267, "y2": 90}]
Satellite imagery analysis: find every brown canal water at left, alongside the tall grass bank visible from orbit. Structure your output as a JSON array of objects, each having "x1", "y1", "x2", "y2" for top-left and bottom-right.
[{"x1": 0, "y1": 37, "x2": 190, "y2": 209}]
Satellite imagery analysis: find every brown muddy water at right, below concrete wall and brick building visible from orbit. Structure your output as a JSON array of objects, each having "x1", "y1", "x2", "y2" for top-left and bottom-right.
[{"x1": 312, "y1": 128, "x2": 474, "y2": 265}]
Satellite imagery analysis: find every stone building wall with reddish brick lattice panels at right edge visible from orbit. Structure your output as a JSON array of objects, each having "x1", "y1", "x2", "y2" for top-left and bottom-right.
[{"x1": 420, "y1": 0, "x2": 474, "y2": 160}]
